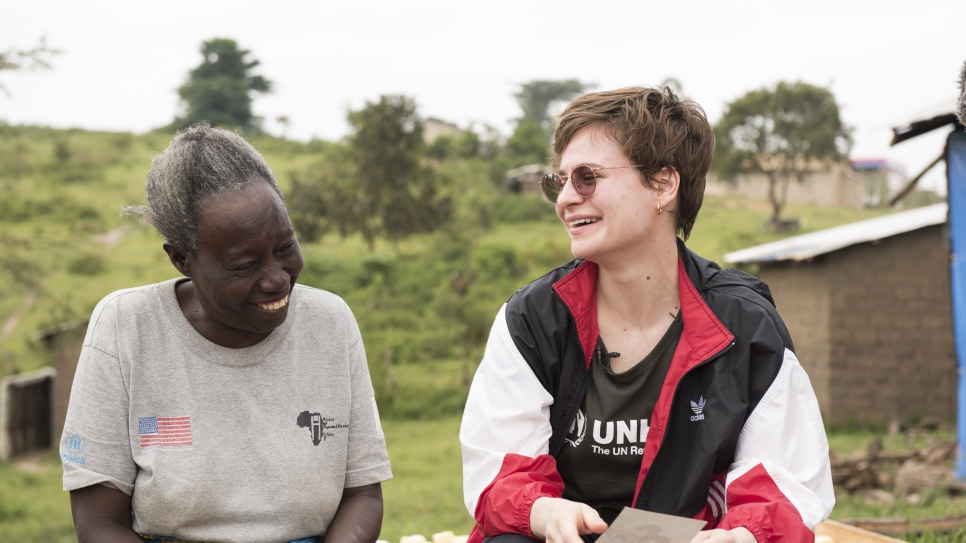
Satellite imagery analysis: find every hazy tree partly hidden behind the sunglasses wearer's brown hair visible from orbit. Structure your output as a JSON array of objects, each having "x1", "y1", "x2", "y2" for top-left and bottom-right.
[{"x1": 507, "y1": 79, "x2": 593, "y2": 162}]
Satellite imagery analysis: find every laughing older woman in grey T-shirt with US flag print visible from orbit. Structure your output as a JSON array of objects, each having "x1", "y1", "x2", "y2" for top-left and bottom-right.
[{"x1": 61, "y1": 125, "x2": 392, "y2": 543}]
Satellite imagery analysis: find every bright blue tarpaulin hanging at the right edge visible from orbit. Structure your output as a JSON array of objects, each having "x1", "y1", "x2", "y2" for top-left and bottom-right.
[{"x1": 946, "y1": 128, "x2": 966, "y2": 481}]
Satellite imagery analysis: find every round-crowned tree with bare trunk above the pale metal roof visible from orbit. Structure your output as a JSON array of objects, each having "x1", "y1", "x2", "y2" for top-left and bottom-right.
[{"x1": 713, "y1": 81, "x2": 852, "y2": 229}]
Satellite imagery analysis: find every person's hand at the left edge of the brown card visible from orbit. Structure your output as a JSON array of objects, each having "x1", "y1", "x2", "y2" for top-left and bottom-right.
[{"x1": 530, "y1": 498, "x2": 607, "y2": 543}]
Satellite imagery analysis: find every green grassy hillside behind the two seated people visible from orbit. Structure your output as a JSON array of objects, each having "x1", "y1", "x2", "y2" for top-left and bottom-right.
[{"x1": 0, "y1": 125, "x2": 900, "y2": 418}]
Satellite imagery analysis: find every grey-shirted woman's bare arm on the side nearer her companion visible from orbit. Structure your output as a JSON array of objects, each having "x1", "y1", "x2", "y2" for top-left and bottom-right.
[{"x1": 325, "y1": 483, "x2": 382, "y2": 543}]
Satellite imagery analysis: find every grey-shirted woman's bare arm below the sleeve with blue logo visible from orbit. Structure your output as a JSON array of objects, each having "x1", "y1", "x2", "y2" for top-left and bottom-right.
[{"x1": 70, "y1": 485, "x2": 144, "y2": 543}]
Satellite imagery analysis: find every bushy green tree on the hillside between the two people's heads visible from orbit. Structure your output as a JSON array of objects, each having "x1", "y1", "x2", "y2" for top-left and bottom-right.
[{"x1": 290, "y1": 96, "x2": 453, "y2": 251}]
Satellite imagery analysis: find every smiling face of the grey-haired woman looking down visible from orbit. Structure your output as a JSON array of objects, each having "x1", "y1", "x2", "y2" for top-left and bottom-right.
[{"x1": 165, "y1": 182, "x2": 303, "y2": 348}]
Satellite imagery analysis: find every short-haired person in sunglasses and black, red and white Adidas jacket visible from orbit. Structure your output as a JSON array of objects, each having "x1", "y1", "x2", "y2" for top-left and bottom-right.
[{"x1": 460, "y1": 88, "x2": 834, "y2": 543}]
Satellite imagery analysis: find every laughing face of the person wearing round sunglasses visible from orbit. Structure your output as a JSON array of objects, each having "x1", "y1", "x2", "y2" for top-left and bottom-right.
[{"x1": 556, "y1": 126, "x2": 674, "y2": 265}]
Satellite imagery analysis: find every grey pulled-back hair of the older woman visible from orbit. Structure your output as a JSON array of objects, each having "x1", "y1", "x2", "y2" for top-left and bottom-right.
[{"x1": 122, "y1": 122, "x2": 282, "y2": 253}]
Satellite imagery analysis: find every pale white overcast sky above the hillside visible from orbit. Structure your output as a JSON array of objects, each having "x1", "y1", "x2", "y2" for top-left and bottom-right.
[{"x1": 0, "y1": 0, "x2": 966, "y2": 193}]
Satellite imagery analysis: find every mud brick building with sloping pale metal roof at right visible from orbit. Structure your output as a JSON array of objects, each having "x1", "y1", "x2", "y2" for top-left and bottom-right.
[{"x1": 725, "y1": 203, "x2": 957, "y2": 424}]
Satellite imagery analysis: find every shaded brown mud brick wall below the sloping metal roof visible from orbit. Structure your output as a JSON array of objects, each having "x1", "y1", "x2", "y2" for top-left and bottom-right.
[{"x1": 830, "y1": 225, "x2": 957, "y2": 421}]
